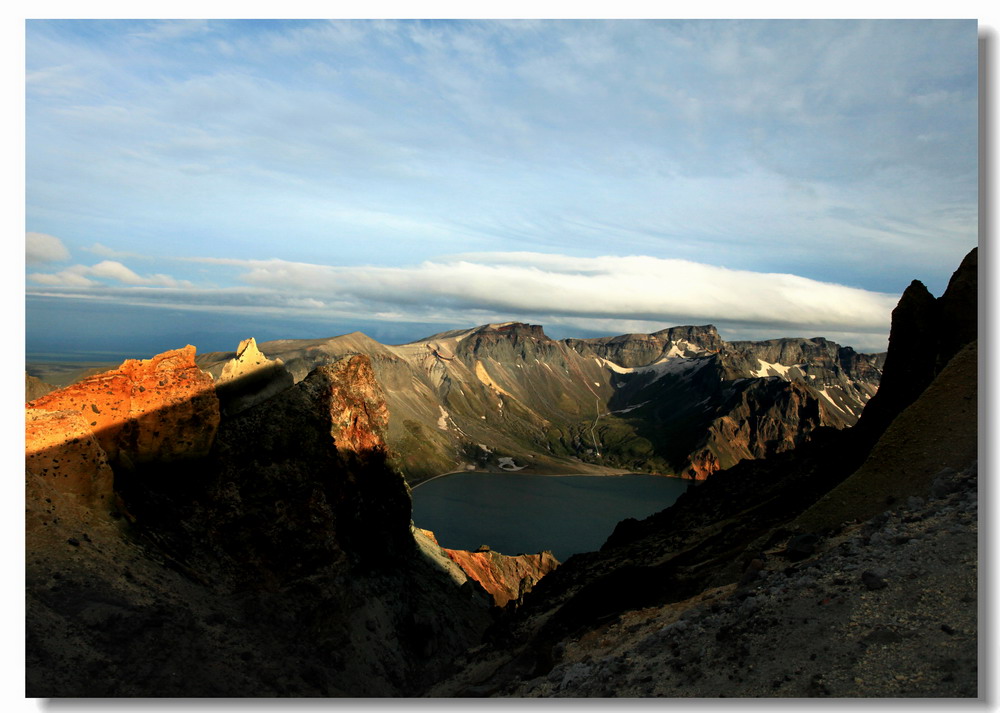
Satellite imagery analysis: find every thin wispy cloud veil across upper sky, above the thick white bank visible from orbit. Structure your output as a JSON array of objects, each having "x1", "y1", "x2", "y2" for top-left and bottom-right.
[{"x1": 28, "y1": 21, "x2": 977, "y2": 298}]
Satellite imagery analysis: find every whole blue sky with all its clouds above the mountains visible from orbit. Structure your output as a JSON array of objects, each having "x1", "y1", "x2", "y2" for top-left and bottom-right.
[{"x1": 25, "y1": 20, "x2": 978, "y2": 356}]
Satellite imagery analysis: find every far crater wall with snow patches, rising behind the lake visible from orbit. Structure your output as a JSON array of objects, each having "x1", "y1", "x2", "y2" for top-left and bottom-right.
[{"x1": 199, "y1": 322, "x2": 883, "y2": 484}]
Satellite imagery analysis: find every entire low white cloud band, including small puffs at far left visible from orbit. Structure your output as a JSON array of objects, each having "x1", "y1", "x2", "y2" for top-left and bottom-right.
[{"x1": 29, "y1": 252, "x2": 898, "y2": 349}]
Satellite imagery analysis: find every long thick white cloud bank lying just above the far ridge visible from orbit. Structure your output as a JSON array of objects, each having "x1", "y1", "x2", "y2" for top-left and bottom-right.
[{"x1": 221, "y1": 252, "x2": 896, "y2": 331}]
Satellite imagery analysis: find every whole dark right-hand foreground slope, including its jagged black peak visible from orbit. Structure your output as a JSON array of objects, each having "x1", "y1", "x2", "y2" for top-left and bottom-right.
[{"x1": 431, "y1": 253, "x2": 977, "y2": 696}]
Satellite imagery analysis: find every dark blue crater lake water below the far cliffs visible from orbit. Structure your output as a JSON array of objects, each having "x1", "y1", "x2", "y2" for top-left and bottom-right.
[{"x1": 413, "y1": 473, "x2": 688, "y2": 561}]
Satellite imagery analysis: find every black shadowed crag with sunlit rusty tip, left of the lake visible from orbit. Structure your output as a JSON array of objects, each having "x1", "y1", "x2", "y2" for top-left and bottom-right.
[{"x1": 197, "y1": 355, "x2": 413, "y2": 580}]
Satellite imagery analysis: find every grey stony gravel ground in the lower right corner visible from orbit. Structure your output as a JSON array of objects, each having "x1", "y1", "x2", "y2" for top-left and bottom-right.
[{"x1": 496, "y1": 464, "x2": 978, "y2": 698}]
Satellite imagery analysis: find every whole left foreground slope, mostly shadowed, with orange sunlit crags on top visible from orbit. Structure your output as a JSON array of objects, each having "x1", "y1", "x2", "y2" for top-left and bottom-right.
[{"x1": 25, "y1": 347, "x2": 500, "y2": 697}]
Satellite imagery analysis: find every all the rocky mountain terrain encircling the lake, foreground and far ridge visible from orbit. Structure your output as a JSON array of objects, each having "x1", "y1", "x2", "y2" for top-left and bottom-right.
[{"x1": 25, "y1": 251, "x2": 980, "y2": 698}]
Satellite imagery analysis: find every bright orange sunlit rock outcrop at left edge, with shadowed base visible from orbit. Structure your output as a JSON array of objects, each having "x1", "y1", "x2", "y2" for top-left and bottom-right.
[{"x1": 28, "y1": 345, "x2": 219, "y2": 467}]
